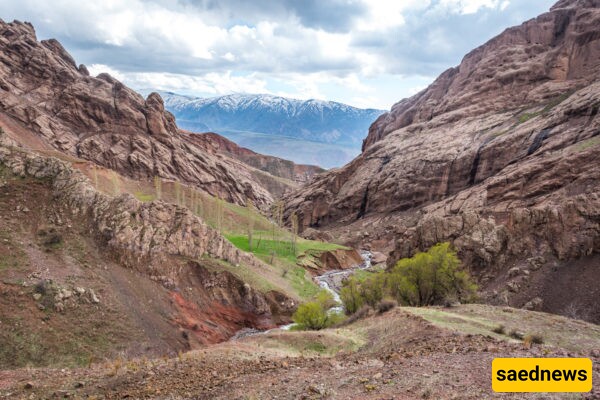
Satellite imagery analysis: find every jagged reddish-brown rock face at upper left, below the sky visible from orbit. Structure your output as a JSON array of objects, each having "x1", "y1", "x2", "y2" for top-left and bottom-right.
[{"x1": 0, "y1": 20, "x2": 272, "y2": 206}]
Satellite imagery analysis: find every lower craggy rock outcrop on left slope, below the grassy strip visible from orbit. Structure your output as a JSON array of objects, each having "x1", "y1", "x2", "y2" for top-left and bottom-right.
[{"x1": 0, "y1": 135, "x2": 276, "y2": 275}]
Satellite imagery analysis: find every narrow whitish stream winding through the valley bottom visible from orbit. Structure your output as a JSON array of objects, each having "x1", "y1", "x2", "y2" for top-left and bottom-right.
[{"x1": 230, "y1": 250, "x2": 373, "y2": 340}]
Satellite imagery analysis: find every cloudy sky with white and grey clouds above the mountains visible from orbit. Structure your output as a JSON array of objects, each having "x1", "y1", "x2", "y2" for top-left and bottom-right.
[{"x1": 0, "y1": 0, "x2": 554, "y2": 109}]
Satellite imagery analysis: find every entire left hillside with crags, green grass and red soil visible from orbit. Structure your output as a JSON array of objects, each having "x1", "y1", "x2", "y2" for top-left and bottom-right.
[{"x1": 0, "y1": 21, "x2": 340, "y2": 369}]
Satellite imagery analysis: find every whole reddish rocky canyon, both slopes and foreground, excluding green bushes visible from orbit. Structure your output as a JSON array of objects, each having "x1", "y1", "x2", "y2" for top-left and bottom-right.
[{"x1": 0, "y1": 0, "x2": 600, "y2": 399}]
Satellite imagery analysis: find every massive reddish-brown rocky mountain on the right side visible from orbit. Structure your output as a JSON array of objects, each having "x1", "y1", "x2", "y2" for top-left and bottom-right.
[{"x1": 286, "y1": 0, "x2": 600, "y2": 321}]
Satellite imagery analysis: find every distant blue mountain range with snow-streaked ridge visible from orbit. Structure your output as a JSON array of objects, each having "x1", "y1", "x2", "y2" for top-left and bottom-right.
[{"x1": 155, "y1": 91, "x2": 383, "y2": 168}]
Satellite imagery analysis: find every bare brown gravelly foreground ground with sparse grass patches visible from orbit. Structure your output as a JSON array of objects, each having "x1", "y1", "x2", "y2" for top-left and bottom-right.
[{"x1": 0, "y1": 305, "x2": 600, "y2": 399}]
